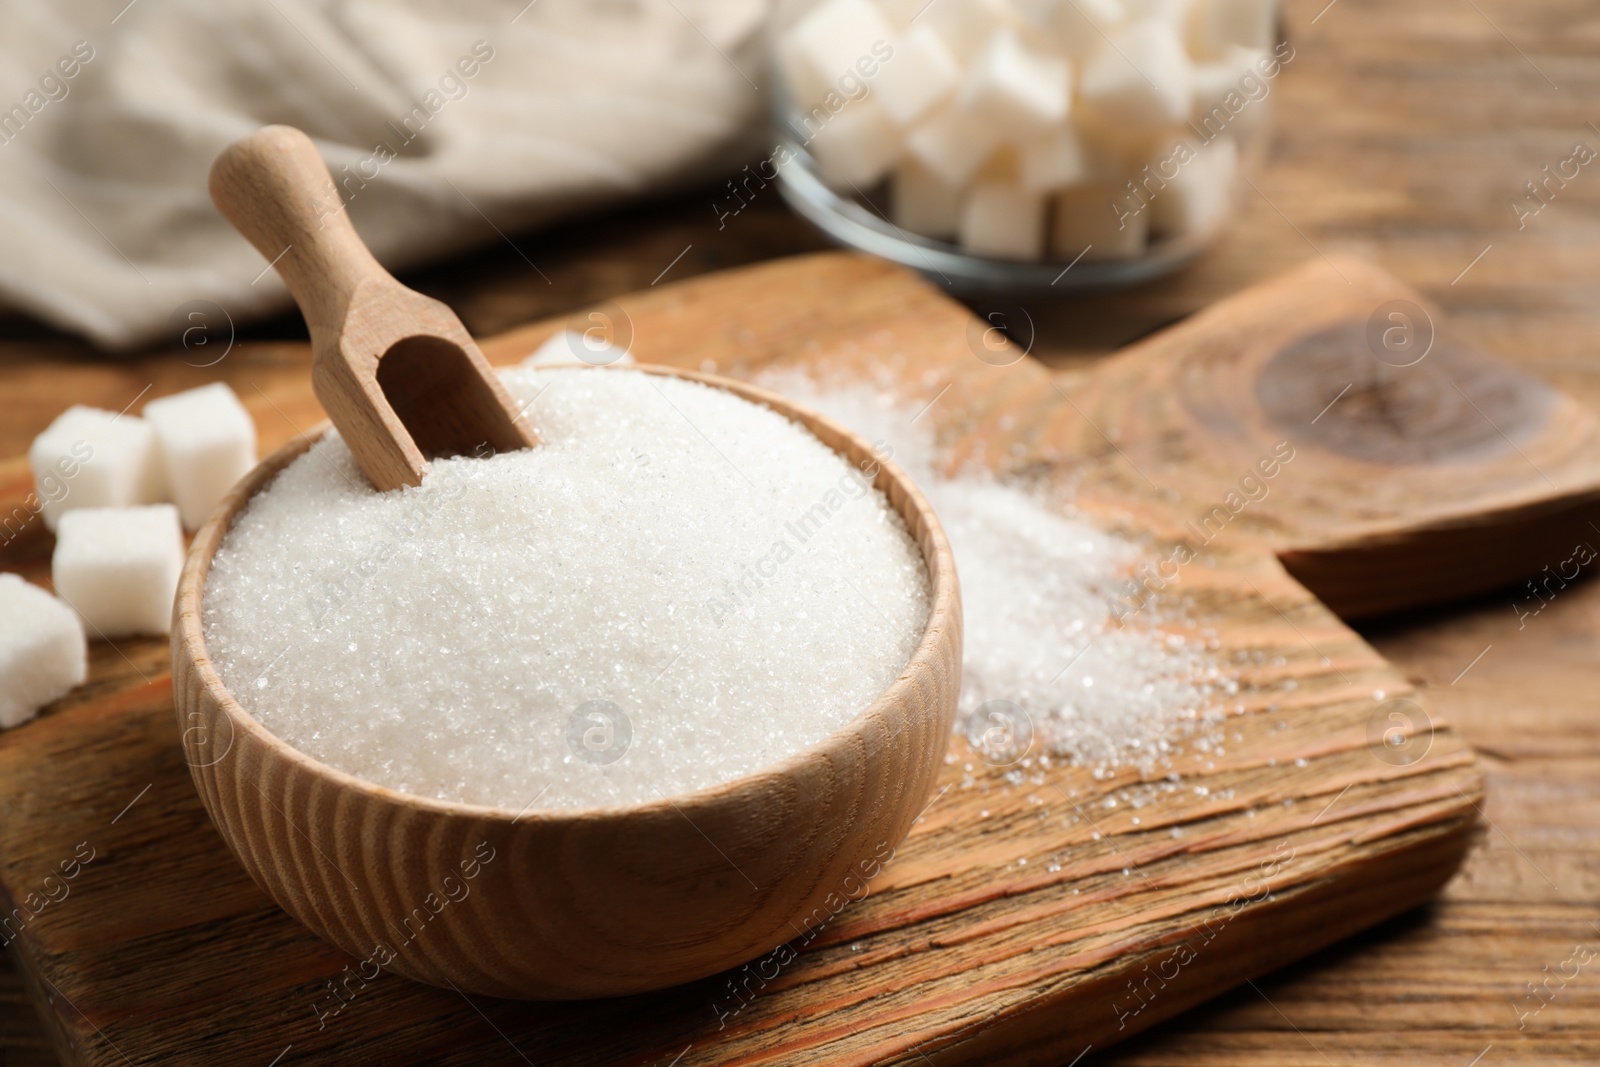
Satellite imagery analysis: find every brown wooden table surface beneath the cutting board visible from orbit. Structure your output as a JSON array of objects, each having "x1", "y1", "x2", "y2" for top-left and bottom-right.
[{"x1": 0, "y1": 0, "x2": 1600, "y2": 1067}]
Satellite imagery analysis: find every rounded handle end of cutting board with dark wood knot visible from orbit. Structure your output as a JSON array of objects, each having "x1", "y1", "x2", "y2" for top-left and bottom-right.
[{"x1": 1030, "y1": 256, "x2": 1600, "y2": 619}]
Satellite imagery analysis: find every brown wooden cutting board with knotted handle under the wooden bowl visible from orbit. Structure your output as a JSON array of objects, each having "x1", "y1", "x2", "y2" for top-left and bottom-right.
[{"x1": 12, "y1": 254, "x2": 1600, "y2": 1067}]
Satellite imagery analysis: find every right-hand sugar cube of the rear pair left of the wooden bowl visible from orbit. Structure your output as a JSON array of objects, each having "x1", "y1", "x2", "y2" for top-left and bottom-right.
[{"x1": 144, "y1": 382, "x2": 256, "y2": 530}]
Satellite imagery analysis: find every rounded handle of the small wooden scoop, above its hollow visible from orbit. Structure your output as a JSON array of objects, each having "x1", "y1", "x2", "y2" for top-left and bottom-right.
[{"x1": 211, "y1": 126, "x2": 398, "y2": 331}]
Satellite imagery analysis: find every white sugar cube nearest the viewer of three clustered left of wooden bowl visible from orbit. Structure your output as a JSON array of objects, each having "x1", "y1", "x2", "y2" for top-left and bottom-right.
[{"x1": 50, "y1": 504, "x2": 184, "y2": 638}]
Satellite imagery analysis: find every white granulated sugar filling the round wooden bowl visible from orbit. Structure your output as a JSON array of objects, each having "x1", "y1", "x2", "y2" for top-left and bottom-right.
[{"x1": 203, "y1": 370, "x2": 928, "y2": 809}]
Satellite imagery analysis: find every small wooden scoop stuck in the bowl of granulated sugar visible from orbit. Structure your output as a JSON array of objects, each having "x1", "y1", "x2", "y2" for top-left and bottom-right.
[{"x1": 211, "y1": 126, "x2": 538, "y2": 490}]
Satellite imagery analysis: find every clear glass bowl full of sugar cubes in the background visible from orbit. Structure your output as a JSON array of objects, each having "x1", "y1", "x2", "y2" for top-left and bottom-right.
[{"x1": 764, "y1": 0, "x2": 1294, "y2": 291}]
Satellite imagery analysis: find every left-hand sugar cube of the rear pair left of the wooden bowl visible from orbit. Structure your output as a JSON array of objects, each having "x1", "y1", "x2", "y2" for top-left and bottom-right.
[{"x1": 27, "y1": 405, "x2": 165, "y2": 530}]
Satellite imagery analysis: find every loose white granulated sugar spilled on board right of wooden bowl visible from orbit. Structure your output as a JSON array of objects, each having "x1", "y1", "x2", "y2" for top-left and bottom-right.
[{"x1": 762, "y1": 373, "x2": 1218, "y2": 777}]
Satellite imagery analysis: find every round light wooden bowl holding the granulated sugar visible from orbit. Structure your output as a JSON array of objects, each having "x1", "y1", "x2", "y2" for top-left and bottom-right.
[{"x1": 173, "y1": 368, "x2": 962, "y2": 1000}]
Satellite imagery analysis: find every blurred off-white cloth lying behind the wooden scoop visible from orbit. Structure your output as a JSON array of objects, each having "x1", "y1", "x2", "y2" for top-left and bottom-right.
[{"x1": 0, "y1": 0, "x2": 765, "y2": 347}]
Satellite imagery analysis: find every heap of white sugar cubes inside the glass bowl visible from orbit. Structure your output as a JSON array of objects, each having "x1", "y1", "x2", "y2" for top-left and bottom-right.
[{"x1": 778, "y1": 0, "x2": 1248, "y2": 271}]
